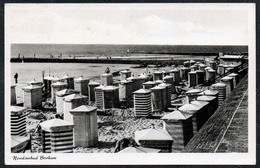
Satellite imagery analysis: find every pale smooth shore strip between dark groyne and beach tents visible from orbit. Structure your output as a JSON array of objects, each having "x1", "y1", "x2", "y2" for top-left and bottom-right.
[{"x1": 10, "y1": 63, "x2": 167, "y2": 102}]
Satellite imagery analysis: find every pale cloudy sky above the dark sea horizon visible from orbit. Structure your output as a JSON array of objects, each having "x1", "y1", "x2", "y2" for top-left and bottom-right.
[{"x1": 5, "y1": 4, "x2": 252, "y2": 45}]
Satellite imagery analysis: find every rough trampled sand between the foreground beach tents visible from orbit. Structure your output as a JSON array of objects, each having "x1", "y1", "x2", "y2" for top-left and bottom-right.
[{"x1": 27, "y1": 108, "x2": 163, "y2": 153}]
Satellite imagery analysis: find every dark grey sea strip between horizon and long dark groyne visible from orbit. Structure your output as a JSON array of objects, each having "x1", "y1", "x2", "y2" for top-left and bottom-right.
[{"x1": 11, "y1": 44, "x2": 248, "y2": 58}]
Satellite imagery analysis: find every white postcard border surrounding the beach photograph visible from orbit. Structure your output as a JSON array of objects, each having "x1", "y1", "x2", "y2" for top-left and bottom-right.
[{"x1": 5, "y1": 3, "x2": 256, "y2": 165}]
